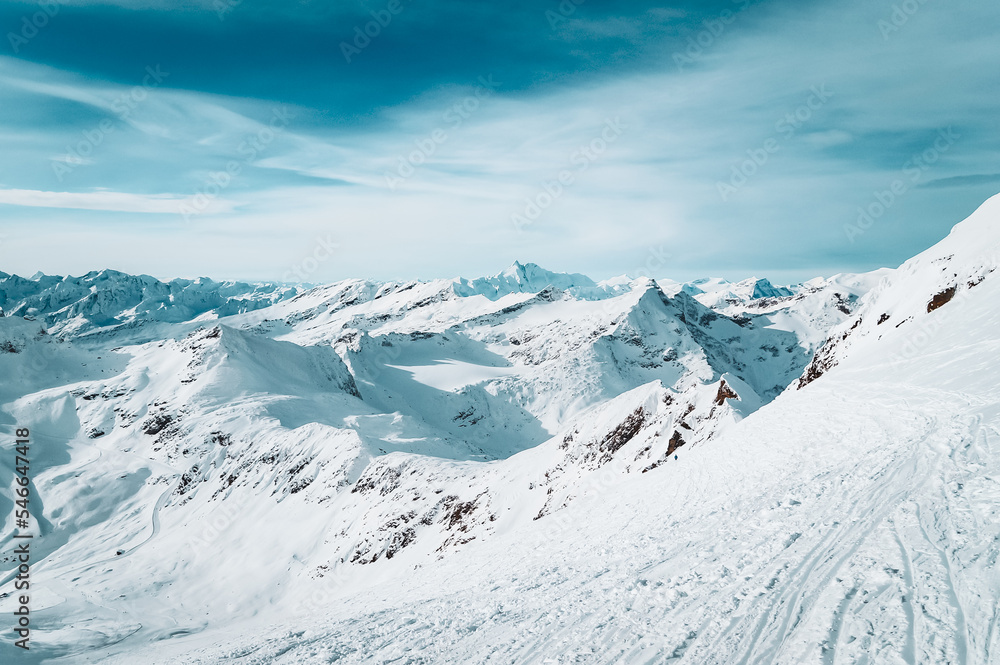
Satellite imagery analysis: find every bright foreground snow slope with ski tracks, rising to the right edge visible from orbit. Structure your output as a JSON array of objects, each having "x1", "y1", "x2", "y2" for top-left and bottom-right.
[{"x1": 74, "y1": 201, "x2": 1000, "y2": 664}]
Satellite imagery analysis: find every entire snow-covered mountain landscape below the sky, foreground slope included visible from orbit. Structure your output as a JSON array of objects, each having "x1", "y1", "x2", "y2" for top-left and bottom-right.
[{"x1": 0, "y1": 198, "x2": 1000, "y2": 665}]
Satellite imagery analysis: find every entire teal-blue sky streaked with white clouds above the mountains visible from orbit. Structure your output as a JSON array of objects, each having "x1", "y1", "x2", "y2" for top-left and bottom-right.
[{"x1": 0, "y1": 0, "x2": 1000, "y2": 282}]
